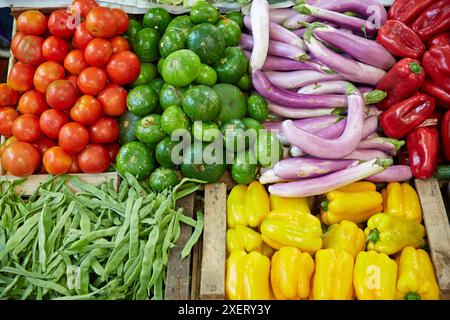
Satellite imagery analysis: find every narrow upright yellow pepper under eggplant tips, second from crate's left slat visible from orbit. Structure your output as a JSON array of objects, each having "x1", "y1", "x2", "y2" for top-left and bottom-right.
[{"x1": 245, "y1": 180, "x2": 270, "y2": 227}]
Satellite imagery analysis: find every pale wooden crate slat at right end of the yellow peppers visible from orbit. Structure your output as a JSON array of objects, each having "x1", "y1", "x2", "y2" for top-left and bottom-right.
[{"x1": 415, "y1": 179, "x2": 450, "y2": 299}]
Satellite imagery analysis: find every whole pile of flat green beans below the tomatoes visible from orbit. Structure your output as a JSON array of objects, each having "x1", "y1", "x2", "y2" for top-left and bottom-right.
[{"x1": 0, "y1": 174, "x2": 203, "y2": 300}]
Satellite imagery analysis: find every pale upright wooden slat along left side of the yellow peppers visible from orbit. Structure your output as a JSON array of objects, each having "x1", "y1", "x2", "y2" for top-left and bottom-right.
[{"x1": 200, "y1": 183, "x2": 227, "y2": 300}]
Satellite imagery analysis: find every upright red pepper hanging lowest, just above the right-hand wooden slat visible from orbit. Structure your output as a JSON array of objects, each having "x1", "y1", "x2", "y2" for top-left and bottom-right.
[{"x1": 406, "y1": 127, "x2": 439, "y2": 179}]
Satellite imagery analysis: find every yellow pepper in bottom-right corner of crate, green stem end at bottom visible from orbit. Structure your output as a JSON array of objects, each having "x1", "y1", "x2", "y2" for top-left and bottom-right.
[{"x1": 397, "y1": 247, "x2": 439, "y2": 300}]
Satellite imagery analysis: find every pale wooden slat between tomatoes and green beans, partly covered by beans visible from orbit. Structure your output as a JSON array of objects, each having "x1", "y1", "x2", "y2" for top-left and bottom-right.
[{"x1": 0, "y1": 172, "x2": 119, "y2": 196}]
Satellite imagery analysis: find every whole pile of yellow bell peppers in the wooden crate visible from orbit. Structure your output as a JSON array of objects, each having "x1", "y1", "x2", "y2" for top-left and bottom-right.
[{"x1": 226, "y1": 181, "x2": 440, "y2": 300}]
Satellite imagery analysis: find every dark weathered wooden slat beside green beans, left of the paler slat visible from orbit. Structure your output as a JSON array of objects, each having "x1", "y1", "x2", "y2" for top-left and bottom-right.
[{"x1": 165, "y1": 194, "x2": 194, "y2": 300}]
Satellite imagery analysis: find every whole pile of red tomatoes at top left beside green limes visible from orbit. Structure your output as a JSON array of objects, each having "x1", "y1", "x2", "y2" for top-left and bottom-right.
[{"x1": 0, "y1": 0, "x2": 140, "y2": 176}]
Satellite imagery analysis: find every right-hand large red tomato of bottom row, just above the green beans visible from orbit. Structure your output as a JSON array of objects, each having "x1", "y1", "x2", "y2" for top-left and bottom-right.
[{"x1": 78, "y1": 144, "x2": 111, "y2": 173}]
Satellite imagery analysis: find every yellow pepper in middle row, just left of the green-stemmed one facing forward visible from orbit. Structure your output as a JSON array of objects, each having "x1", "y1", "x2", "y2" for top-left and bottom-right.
[{"x1": 323, "y1": 220, "x2": 366, "y2": 258}]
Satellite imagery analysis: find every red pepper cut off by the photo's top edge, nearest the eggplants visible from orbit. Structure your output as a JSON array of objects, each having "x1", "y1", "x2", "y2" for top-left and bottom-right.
[{"x1": 388, "y1": 0, "x2": 437, "y2": 23}]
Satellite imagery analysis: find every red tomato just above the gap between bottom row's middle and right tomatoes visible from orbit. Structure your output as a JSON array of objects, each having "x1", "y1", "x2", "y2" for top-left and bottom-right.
[{"x1": 58, "y1": 122, "x2": 89, "y2": 152}]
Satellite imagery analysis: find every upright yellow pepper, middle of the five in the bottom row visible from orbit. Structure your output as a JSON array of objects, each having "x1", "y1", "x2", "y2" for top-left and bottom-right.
[{"x1": 312, "y1": 249, "x2": 354, "y2": 300}]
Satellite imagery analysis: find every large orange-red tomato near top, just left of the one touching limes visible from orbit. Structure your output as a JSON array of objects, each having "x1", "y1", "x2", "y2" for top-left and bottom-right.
[{"x1": 86, "y1": 7, "x2": 118, "y2": 38}]
